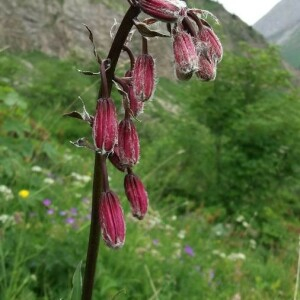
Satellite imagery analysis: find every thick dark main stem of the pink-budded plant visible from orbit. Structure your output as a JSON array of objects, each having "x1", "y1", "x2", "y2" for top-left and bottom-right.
[{"x1": 81, "y1": 6, "x2": 140, "y2": 300}]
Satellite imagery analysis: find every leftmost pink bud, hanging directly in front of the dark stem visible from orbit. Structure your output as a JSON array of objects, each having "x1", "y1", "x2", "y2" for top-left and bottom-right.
[{"x1": 93, "y1": 98, "x2": 118, "y2": 154}]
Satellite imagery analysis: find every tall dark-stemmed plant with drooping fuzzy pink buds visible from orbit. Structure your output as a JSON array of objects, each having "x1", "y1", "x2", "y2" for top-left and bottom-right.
[{"x1": 66, "y1": 0, "x2": 223, "y2": 300}]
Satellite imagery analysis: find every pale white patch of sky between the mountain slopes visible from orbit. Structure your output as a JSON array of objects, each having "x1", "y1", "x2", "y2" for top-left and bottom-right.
[{"x1": 218, "y1": 0, "x2": 280, "y2": 25}]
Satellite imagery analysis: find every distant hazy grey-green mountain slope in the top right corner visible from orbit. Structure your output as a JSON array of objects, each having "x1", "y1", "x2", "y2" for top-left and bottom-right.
[{"x1": 254, "y1": 0, "x2": 300, "y2": 68}]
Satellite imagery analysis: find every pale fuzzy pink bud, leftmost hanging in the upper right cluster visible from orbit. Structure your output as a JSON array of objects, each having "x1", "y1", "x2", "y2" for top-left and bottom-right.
[{"x1": 173, "y1": 30, "x2": 198, "y2": 74}]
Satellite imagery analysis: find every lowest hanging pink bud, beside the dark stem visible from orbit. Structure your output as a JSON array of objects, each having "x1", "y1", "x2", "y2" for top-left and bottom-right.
[{"x1": 99, "y1": 191, "x2": 126, "y2": 248}]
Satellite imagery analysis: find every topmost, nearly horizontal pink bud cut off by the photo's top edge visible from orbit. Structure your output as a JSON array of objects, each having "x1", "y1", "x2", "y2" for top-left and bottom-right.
[{"x1": 138, "y1": 0, "x2": 186, "y2": 23}]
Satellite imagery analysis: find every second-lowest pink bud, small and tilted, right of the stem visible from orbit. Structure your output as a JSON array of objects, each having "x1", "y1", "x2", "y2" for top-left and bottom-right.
[{"x1": 124, "y1": 173, "x2": 148, "y2": 220}]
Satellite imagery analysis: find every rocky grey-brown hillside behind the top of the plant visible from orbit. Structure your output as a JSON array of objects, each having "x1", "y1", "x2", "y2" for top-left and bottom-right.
[{"x1": 0, "y1": 0, "x2": 266, "y2": 75}]
